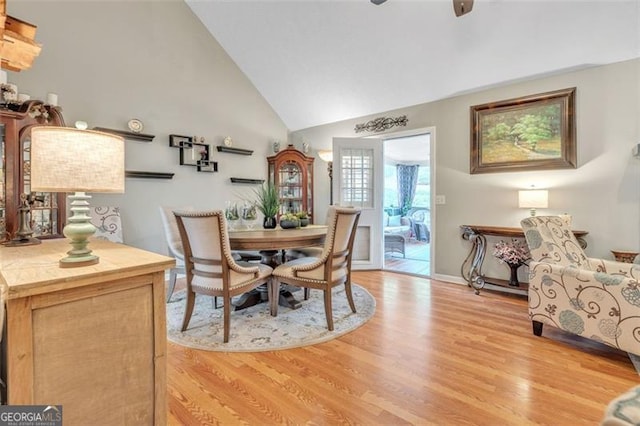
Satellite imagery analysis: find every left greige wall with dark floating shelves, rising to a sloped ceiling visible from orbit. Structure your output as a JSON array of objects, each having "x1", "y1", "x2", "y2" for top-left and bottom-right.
[{"x1": 7, "y1": 1, "x2": 287, "y2": 253}]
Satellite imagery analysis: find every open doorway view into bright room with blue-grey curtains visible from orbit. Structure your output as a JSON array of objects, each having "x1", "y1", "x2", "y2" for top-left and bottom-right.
[{"x1": 383, "y1": 132, "x2": 432, "y2": 276}]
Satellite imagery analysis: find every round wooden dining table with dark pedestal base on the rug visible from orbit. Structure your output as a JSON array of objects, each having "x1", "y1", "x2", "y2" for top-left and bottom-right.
[{"x1": 228, "y1": 225, "x2": 327, "y2": 310}]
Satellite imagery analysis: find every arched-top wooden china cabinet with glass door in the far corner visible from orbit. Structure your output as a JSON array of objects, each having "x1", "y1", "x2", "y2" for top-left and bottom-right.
[{"x1": 267, "y1": 145, "x2": 314, "y2": 223}]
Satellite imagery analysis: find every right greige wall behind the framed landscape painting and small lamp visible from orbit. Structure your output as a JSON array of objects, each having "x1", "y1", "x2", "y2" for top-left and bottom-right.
[{"x1": 290, "y1": 60, "x2": 640, "y2": 277}]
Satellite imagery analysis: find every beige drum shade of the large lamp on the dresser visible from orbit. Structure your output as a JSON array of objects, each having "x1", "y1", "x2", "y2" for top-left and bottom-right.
[{"x1": 31, "y1": 126, "x2": 124, "y2": 192}]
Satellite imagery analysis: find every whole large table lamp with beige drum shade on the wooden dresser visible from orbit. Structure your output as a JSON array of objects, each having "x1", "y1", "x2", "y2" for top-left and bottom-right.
[{"x1": 31, "y1": 126, "x2": 124, "y2": 268}]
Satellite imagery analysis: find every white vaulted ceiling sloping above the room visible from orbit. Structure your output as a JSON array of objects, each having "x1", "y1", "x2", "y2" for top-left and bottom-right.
[{"x1": 186, "y1": 0, "x2": 640, "y2": 131}]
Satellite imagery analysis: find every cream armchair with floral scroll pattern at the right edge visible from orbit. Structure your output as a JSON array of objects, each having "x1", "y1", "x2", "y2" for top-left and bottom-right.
[{"x1": 520, "y1": 216, "x2": 640, "y2": 371}]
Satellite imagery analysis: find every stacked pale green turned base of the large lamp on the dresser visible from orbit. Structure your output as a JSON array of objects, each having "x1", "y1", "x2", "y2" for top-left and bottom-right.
[{"x1": 60, "y1": 192, "x2": 100, "y2": 268}]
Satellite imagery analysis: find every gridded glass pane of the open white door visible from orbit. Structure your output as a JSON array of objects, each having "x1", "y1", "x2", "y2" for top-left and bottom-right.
[{"x1": 340, "y1": 148, "x2": 373, "y2": 208}]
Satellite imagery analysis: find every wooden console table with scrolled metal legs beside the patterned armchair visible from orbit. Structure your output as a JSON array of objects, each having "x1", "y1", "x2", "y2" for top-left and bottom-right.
[{"x1": 460, "y1": 225, "x2": 589, "y2": 295}]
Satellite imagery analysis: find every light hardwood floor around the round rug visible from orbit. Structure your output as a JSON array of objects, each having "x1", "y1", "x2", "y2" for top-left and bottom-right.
[{"x1": 167, "y1": 271, "x2": 638, "y2": 425}]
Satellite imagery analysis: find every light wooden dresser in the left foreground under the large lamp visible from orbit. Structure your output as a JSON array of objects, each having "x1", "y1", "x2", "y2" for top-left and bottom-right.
[{"x1": 0, "y1": 239, "x2": 174, "y2": 425}]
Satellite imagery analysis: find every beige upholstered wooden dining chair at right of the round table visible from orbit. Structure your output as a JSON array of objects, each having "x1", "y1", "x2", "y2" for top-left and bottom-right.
[{"x1": 269, "y1": 206, "x2": 360, "y2": 331}]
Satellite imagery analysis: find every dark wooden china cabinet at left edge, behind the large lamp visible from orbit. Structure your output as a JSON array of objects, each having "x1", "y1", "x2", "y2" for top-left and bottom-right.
[{"x1": 0, "y1": 101, "x2": 66, "y2": 241}]
